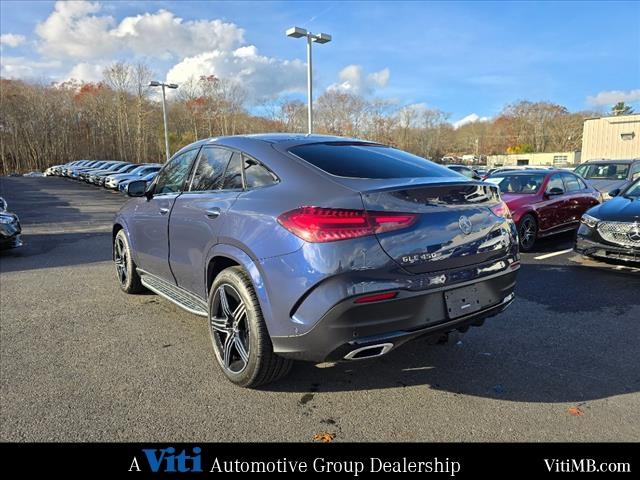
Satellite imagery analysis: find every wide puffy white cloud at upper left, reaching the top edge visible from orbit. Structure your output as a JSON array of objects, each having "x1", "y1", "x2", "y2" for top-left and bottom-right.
[{"x1": 36, "y1": 1, "x2": 244, "y2": 60}]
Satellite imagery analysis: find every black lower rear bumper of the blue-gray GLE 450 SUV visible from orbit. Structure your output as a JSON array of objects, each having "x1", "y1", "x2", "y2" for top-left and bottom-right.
[{"x1": 271, "y1": 270, "x2": 517, "y2": 362}]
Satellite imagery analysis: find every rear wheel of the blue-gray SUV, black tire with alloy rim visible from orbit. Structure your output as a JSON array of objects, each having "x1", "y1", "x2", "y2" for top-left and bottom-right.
[{"x1": 209, "y1": 267, "x2": 293, "y2": 388}]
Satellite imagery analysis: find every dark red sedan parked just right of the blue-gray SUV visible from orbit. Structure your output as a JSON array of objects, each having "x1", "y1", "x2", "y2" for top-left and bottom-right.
[{"x1": 486, "y1": 170, "x2": 602, "y2": 252}]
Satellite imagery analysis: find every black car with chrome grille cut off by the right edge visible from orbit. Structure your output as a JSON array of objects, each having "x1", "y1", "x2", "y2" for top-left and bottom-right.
[{"x1": 575, "y1": 179, "x2": 640, "y2": 262}]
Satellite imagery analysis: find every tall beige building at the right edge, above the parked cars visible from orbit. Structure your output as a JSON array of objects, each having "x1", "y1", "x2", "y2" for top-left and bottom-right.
[{"x1": 582, "y1": 114, "x2": 640, "y2": 162}]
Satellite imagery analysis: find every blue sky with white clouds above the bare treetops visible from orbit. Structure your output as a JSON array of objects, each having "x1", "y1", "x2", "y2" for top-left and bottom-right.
[{"x1": 0, "y1": 0, "x2": 640, "y2": 125}]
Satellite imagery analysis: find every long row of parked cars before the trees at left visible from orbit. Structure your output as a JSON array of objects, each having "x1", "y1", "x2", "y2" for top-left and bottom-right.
[{"x1": 45, "y1": 160, "x2": 162, "y2": 191}]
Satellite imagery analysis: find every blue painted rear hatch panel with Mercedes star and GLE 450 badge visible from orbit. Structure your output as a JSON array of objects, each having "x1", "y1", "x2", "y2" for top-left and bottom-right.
[{"x1": 362, "y1": 181, "x2": 510, "y2": 273}]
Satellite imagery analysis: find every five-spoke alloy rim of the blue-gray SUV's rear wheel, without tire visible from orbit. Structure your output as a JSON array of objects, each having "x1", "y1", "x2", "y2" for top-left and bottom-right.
[{"x1": 209, "y1": 283, "x2": 249, "y2": 374}]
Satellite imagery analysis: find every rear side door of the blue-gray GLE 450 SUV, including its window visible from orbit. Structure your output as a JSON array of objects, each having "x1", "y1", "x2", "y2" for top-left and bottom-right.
[{"x1": 169, "y1": 146, "x2": 243, "y2": 299}]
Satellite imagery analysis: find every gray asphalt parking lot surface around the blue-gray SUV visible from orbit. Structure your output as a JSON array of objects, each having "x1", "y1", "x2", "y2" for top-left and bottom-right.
[{"x1": 0, "y1": 177, "x2": 640, "y2": 442}]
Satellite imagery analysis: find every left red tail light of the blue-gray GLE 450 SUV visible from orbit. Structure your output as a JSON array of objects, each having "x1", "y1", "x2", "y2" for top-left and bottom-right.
[{"x1": 278, "y1": 207, "x2": 416, "y2": 243}]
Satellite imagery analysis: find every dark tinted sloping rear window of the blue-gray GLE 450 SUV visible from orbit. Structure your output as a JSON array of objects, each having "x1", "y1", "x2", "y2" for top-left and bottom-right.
[{"x1": 289, "y1": 142, "x2": 457, "y2": 178}]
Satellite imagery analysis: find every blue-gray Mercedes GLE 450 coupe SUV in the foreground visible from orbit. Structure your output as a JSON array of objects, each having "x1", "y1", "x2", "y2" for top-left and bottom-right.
[{"x1": 113, "y1": 134, "x2": 520, "y2": 387}]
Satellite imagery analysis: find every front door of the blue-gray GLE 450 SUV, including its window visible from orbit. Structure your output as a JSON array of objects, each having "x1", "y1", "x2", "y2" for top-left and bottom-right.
[{"x1": 129, "y1": 148, "x2": 198, "y2": 283}]
